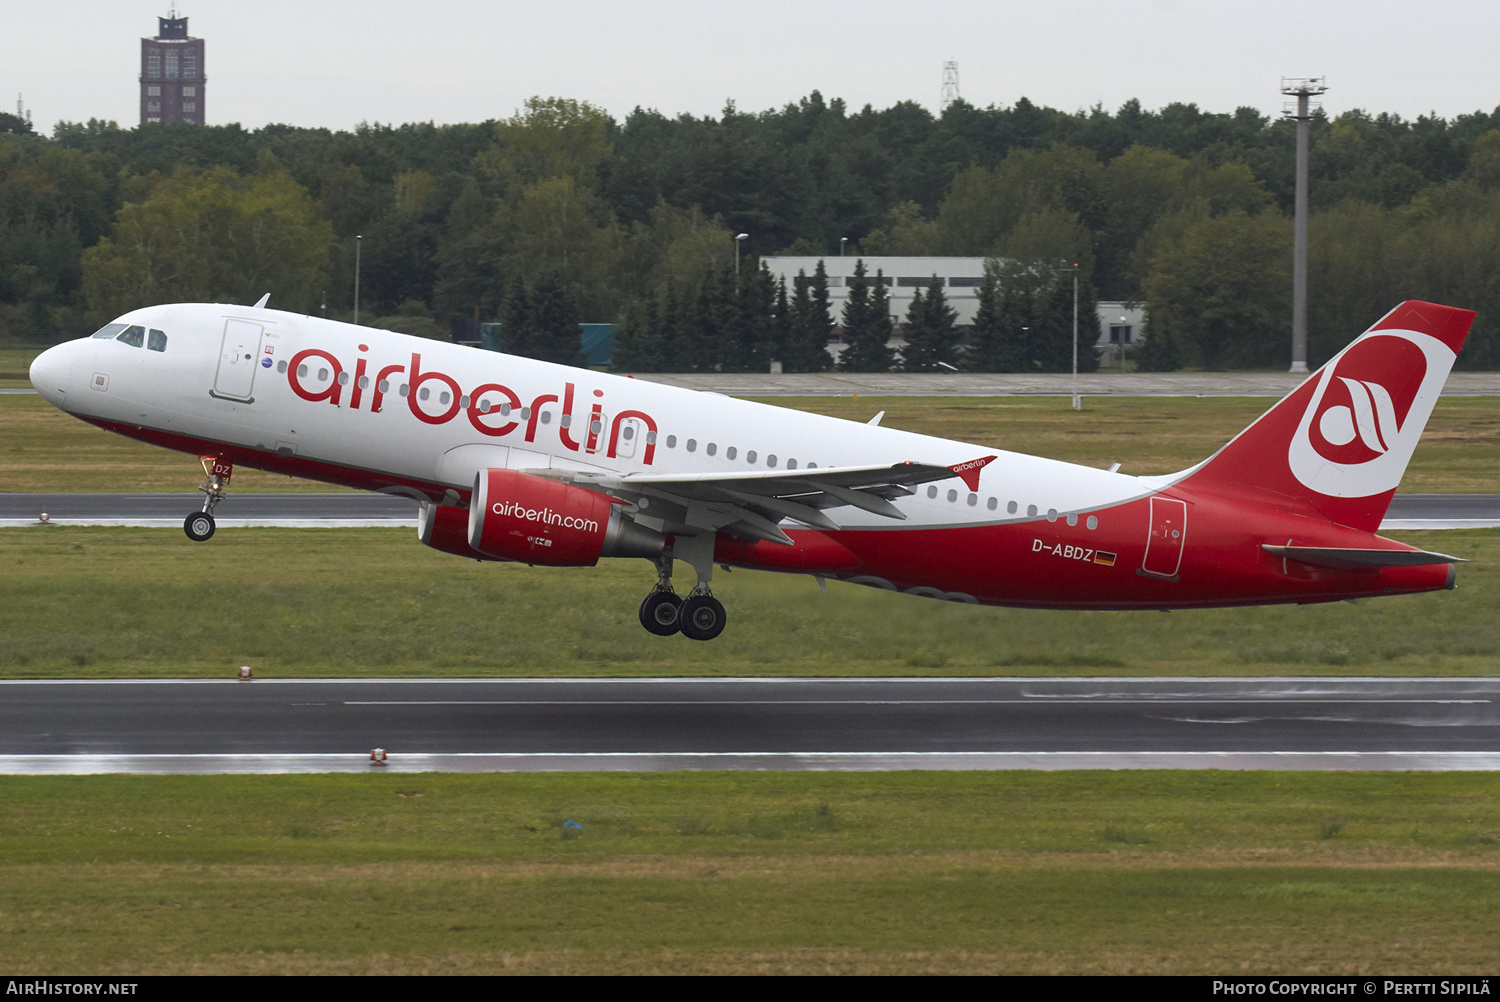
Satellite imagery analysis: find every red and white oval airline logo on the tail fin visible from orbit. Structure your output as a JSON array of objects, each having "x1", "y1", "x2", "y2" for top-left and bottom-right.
[{"x1": 1287, "y1": 330, "x2": 1454, "y2": 498}]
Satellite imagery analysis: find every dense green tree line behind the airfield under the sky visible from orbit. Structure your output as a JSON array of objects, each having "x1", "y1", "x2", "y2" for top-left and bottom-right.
[{"x1": 0, "y1": 93, "x2": 1500, "y2": 371}]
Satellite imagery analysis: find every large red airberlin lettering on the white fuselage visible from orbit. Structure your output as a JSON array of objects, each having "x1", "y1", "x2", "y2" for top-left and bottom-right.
[{"x1": 287, "y1": 345, "x2": 657, "y2": 467}]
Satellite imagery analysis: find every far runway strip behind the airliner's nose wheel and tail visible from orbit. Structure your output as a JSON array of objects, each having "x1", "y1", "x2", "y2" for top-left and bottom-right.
[{"x1": 0, "y1": 492, "x2": 1500, "y2": 530}]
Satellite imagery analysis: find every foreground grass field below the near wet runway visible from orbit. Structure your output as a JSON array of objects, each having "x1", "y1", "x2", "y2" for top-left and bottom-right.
[{"x1": 0, "y1": 771, "x2": 1500, "y2": 975}]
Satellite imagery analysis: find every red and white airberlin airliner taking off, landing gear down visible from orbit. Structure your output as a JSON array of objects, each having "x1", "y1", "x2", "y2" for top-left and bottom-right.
[{"x1": 32, "y1": 300, "x2": 1475, "y2": 641}]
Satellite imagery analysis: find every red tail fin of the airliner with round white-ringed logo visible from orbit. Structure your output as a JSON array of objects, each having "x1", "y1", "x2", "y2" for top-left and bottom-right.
[{"x1": 1181, "y1": 300, "x2": 1475, "y2": 533}]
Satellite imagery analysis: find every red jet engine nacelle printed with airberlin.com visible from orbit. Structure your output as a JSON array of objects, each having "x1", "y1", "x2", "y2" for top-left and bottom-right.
[{"x1": 468, "y1": 470, "x2": 666, "y2": 567}]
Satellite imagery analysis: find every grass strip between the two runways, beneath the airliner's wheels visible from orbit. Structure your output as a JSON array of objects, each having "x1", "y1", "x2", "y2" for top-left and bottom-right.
[{"x1": 0, "y1": 525, "x2": 1500, "y2": 678}]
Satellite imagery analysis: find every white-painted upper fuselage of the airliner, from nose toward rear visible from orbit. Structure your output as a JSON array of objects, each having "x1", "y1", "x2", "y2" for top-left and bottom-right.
[{"x1": 38, "y1": 305, "x2": 1157, "y2": 528}]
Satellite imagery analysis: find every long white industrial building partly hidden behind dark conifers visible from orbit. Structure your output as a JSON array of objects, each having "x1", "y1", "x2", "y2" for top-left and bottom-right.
[{"x1": 761, "y1": 257, "x2": 1145, "y2": 352}]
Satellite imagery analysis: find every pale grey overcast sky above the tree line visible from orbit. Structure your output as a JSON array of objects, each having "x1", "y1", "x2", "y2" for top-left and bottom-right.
[{"x1": 0, "y1": 0, "x2": 1500, "y2": 132}]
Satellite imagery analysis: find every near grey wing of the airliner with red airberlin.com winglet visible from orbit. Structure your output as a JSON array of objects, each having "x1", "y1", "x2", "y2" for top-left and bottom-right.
[{"x1": 536, "y1": 462, "x2": 983, "y2": 546}]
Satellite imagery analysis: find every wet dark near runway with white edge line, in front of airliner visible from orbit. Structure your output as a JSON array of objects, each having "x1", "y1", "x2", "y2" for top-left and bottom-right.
[{"x1": 0, "y1": 678, "x2": 1500, "y2": 774}]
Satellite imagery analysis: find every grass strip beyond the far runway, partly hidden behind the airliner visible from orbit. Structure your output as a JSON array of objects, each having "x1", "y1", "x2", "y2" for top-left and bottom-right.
[{"x1": 0, "y1": 396, "x2": 1500, "y2": 494}]
